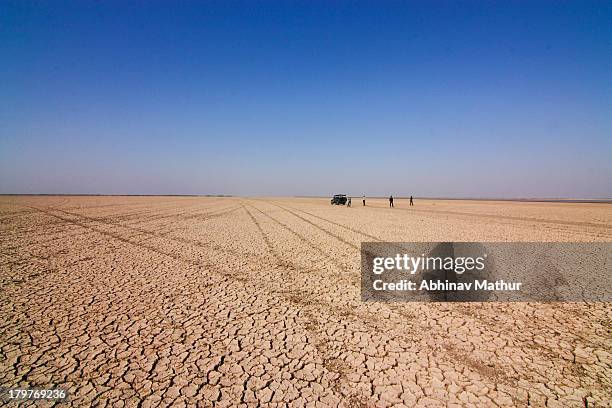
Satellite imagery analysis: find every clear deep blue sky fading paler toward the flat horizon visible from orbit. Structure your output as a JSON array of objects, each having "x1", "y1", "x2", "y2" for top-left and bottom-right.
[{"x1": 0, "y1": 0, "x2": 612, "y2": 198}]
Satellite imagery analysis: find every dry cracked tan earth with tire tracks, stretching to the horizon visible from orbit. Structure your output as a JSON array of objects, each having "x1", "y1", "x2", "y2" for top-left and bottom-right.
[{"x1": 0, "y1": 196, "x2": 612, "y2": 407}]
